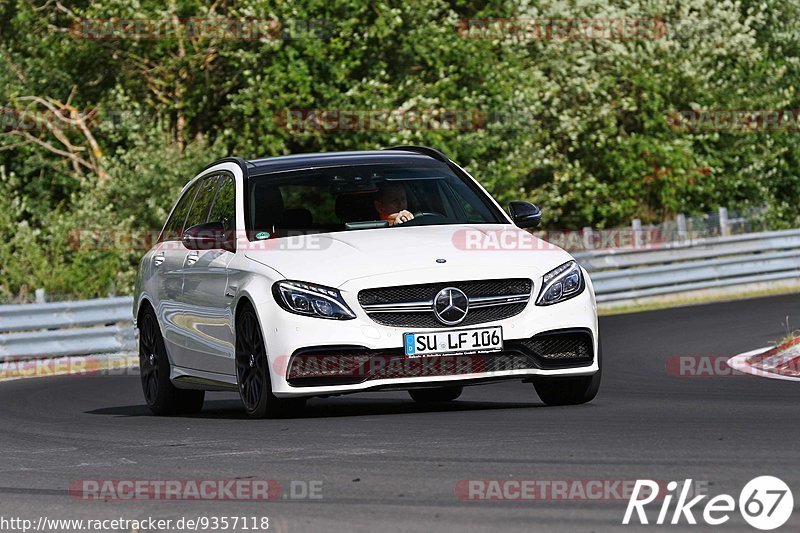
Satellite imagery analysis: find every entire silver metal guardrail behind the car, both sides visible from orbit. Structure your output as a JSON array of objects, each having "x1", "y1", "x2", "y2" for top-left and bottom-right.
[{"x1": 0, "y1": 229, "x2": 800, "y2": 362}]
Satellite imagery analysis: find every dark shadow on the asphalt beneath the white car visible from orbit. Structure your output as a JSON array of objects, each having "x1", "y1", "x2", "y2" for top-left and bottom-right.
[{"x1": 85, "y1": 398, "x2": 546, "y2": 420}]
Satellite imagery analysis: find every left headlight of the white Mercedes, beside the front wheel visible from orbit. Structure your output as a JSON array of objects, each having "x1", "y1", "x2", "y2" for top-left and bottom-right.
[{"x1": 272, "y1": 281, "x2": 356, "y2": 320}]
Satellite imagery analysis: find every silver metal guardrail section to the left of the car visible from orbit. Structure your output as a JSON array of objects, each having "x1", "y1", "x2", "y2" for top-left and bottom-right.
[{"x1": 0, "y1": 296, "x2": 136, "y2": 361}]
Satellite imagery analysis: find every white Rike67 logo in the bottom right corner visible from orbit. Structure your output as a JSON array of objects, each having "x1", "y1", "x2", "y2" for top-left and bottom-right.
[{"x1": 622, "y1": 476, "x2": 794, "y2": 530}]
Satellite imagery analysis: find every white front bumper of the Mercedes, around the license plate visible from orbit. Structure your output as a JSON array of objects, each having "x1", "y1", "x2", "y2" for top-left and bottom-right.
[{"x1": 259, "y1": 274, "x2": 599, "y2": 397}]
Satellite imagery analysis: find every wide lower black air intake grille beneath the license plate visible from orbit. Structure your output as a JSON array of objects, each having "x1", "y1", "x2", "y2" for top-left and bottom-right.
[{"x1": 286, "y1": 329, "x2": 593, "y2": 387}]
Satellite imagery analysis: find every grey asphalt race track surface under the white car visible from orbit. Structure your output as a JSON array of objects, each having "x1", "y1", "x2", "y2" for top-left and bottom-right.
[{"x1": 0, "y1": 295, "x2": 800, "y2": 532}]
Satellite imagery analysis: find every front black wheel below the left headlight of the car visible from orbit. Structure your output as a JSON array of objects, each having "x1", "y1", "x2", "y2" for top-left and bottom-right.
[{"x1": 236, "y1": 305, "x2": 306, "y2": 418}]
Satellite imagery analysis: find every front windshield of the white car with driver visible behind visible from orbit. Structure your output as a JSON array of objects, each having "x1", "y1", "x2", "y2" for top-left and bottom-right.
[{"x1": 246, "y1": 164, "x2": 508, "y2": 240}]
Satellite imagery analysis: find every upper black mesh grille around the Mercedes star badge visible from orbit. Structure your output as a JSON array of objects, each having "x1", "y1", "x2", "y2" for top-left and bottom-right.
[{"x1": 358, "y1": 278, "x2": 533, "y2": 328}]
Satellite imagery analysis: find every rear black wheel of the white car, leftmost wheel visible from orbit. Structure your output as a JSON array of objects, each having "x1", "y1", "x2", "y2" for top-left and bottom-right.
[{"x1": 139, "y1": 309, "x2": 206, "y2": 415}]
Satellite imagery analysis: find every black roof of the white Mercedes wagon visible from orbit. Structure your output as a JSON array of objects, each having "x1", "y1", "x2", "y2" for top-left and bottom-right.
[{"x1": 204, "y1": 146, "x2": 447, "y2": 177}]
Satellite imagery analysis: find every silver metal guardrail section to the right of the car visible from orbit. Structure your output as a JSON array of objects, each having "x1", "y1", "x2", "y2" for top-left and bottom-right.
[{"x1": 575, "y1": 229, "x2": 800, "y2": 303}]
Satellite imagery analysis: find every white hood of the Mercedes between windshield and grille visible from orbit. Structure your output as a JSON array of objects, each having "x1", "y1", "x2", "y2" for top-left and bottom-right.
[{"x1": 245, "y1": 224, "x2": 572, "y2": 287}]
